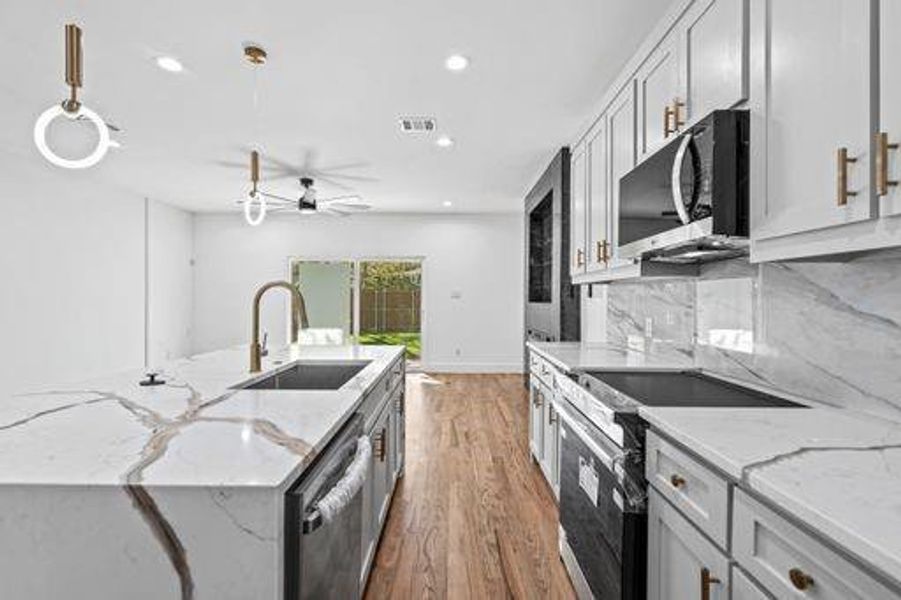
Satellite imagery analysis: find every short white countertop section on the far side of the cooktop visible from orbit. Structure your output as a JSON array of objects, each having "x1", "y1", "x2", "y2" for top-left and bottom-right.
[{"x1": 528, "y1": 342, "x2": 694, "y2": 371}]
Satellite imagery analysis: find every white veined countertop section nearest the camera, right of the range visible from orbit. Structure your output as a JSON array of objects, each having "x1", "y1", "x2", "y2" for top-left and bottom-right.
[{"x1": 640, "y1": 407, "x2": 901, "y2": 583}]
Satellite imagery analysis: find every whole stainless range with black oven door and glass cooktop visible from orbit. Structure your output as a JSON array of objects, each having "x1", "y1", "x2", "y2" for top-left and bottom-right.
[{"x1": 555, "y1": 371, "x2": 804, "y2": 600}]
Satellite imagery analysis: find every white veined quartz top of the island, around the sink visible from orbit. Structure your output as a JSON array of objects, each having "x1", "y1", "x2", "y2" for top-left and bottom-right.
[{"x1": 0, "y1": 346, "x2": 403, "y2": 488}]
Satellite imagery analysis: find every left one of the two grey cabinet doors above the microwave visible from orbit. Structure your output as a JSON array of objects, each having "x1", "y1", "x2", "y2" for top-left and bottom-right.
[{"x1": 636, "y1": 30, "x2": 684, "y2": 157}]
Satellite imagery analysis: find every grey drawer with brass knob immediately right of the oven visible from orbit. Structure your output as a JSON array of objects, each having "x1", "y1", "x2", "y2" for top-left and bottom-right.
[{"x1": 645, "y1": 431, "x2": 729, "y2": 549}]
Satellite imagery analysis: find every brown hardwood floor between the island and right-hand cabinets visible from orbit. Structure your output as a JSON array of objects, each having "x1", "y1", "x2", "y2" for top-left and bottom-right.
[{"x1": 366, "y1": 374, "x2": 575, "y2": 600}]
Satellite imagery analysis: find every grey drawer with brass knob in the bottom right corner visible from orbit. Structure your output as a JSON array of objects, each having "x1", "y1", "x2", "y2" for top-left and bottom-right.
[{"x1": 732, "y1": 490, "x2": 901, "y2": 600}]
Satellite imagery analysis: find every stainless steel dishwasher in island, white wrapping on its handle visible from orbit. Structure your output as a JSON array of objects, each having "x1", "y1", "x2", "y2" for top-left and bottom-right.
[{"x1": 285, "y1": 414, "x2": 371, "y2": 600}]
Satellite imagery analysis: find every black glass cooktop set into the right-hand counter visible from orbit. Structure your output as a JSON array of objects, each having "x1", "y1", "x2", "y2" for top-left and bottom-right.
[{"x1": 580, "y1": 371, "x2": 805, "y2": 408}]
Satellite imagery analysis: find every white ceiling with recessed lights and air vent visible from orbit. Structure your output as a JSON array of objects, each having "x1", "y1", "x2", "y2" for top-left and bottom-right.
[{"x1": 0, "y1": 0, "x2": 670, "y2": 212}]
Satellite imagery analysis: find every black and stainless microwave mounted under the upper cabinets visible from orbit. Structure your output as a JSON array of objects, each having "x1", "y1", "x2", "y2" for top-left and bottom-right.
[{"x1": 618, "y1": 110, "x2": 749, "y2": 263}]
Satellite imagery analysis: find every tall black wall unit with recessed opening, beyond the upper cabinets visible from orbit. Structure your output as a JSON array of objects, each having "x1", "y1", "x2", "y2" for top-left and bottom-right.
[{"x1": 524, "y1": 148, "x2": 580, "y2": 386}]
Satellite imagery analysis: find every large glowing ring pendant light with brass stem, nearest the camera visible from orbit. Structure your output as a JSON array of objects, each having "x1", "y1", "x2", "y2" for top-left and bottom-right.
[{"x1": 34, "y1": 23, "x2": 110, "y2": 169}]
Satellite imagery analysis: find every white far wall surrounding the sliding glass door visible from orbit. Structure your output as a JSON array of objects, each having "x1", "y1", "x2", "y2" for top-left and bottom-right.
[{"x1": 194, "y1": 214, "x2": 523, "y2": 372}]
